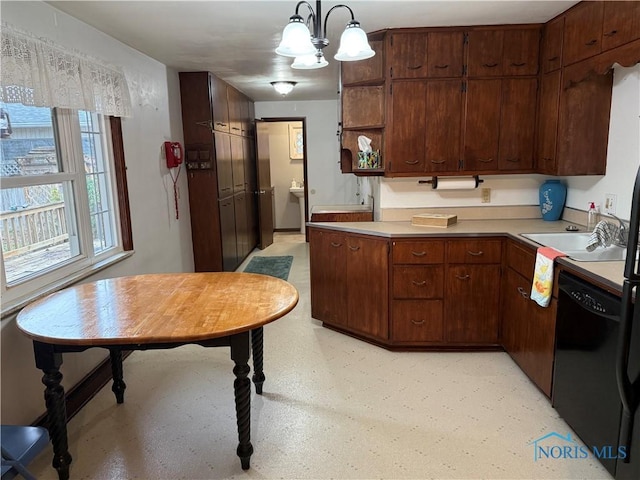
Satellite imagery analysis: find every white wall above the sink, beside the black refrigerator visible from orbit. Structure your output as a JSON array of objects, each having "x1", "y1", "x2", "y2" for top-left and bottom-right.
[{"x1": 567, "y1": 65, "x2": 640, "y2": 219}]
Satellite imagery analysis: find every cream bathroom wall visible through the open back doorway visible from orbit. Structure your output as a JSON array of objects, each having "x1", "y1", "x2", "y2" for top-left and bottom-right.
[{"x1": 267, "y1": 122, "x2": 304, "y2": 229}]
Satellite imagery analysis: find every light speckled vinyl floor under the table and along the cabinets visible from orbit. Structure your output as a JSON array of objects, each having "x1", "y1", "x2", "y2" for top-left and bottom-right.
[{"x1": 31, "y1": 234, "x2": 611, "y2": 480}]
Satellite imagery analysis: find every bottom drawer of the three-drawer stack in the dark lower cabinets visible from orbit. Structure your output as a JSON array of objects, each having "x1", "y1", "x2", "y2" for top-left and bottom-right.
[{"x1": 391, "y1": 300, "x2": 443, "y2": 342}]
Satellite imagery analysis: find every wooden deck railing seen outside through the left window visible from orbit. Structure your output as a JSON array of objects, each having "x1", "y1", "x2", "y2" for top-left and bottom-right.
[{"x1": 0, "y1": 202, "x2": 69, "y2": 258}]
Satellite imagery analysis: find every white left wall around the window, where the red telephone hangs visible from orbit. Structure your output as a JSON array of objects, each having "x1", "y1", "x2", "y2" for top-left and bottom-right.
[{"x1": 0, "y1": 2, "x2": 193, "y2": 423}]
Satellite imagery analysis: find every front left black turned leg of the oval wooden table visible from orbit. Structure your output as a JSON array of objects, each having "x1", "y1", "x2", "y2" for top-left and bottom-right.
[{"x1": 33, "y1": 341, "x2": 71, "y2": 480}]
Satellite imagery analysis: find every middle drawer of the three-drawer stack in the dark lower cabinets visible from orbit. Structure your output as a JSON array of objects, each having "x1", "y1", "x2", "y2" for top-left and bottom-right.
[{"x1": 393, "y1": 265, "x2": 444, "y2": 298}]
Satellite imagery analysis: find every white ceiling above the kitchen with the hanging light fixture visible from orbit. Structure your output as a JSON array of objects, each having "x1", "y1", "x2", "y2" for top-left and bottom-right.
[{"x1": 47, "y1": 0, "x2": 577, "y2": 101}]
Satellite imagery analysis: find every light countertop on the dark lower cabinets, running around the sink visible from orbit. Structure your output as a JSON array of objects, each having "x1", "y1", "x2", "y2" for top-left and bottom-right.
[{"x1": 308, "y1": 219, "x2": 624, "y2": 295}]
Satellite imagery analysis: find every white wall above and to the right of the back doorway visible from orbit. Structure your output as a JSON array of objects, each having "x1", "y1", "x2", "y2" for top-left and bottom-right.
[{"x1": 255, "y1": 100, "x2": 360, "y2": 218}]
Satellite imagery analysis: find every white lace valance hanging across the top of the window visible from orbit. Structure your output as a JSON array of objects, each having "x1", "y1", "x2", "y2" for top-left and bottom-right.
[{"x1": 0, "y1": 23, "x2": 131, "y2": 117}]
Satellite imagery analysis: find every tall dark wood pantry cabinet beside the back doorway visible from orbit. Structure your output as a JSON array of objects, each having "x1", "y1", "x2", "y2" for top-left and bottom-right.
[{"x1": 179, "y1": 72, "x2": 258, "y2": 272}]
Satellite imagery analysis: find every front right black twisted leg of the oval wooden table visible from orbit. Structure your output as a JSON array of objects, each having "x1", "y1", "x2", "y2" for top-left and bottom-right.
[{"x1": 230, "y1": 332, "x2": 253, "y2": 470}]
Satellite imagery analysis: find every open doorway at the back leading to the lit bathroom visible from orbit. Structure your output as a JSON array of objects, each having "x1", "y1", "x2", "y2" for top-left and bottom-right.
[{"x1": 258, "y1": 117, "x2": 309, "y2": 240}]
